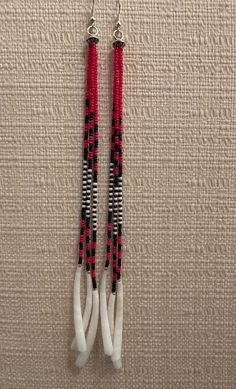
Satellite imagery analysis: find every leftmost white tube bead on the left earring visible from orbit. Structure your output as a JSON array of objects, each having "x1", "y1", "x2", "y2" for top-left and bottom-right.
[{"x1": 72, "y1": 266, "x2": 87, "y2": 352}]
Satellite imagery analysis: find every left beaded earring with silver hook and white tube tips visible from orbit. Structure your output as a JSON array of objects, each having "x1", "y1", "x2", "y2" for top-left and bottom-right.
[{"x1": 71, "y1": 0, "x2": 99, "y2": 368}]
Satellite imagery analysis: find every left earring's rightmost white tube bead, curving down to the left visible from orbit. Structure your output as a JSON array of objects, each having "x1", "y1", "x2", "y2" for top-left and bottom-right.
[{"x1": 75, "y1": 289, "x2": 99, "y2": 368}]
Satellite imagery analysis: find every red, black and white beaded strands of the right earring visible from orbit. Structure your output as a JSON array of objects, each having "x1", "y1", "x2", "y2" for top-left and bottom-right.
[{"x1": 105, "y1": 45, "x2": 123, "y2": 293}]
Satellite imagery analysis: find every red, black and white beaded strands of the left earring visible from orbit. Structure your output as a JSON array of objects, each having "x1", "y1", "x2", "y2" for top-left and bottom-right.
[{"x1": 78, "y1": 39, "x2": 98, "y2": 289}]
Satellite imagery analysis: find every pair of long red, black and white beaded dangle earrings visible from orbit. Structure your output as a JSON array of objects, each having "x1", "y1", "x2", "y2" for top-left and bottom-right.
[{"x1": 71, "y1": 1, "x2": 125, "y2": 368}]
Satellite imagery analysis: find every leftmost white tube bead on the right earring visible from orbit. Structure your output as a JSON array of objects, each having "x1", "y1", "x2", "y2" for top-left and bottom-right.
[{"x1": 100, "y1": 270, "x2": 113, "y2": 356}]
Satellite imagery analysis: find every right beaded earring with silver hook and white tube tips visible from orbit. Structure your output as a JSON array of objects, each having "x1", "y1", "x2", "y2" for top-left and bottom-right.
[{"x1": 100, "y1": 2, "x2": 125, "y2": 369}]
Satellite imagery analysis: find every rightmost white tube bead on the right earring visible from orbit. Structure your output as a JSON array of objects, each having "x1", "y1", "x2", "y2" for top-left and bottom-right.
[{"x1": 111, "y1": 279, "x2": 123, "y2": 369}]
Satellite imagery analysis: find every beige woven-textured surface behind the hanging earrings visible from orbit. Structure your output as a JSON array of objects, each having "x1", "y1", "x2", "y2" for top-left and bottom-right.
[{"x1": 0, "y1": 0, "x2": 236, "y2": 389}]
